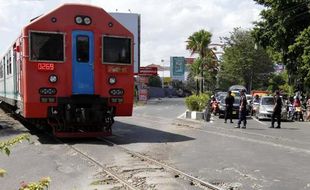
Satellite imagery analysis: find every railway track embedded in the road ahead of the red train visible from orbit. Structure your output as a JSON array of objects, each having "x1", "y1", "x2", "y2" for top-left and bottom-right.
[{"x1": 54, "y1": 134, "x2": 223, "y2": 190}]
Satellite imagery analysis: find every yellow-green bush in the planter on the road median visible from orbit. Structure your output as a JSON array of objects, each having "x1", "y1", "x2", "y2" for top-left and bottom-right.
[{"x1": 185, "y1": 94, "x2": 210, "y2": 111}]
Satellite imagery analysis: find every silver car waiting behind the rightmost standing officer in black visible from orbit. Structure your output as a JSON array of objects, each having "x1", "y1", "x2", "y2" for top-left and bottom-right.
[{"x1": 256, "y1": 96, "x2": 287, "y2": 120}]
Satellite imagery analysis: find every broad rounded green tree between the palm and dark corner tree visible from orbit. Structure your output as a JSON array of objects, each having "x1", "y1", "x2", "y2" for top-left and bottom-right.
[{"x1": 219, "y1": 28, "x2": 274, "y2": 90}]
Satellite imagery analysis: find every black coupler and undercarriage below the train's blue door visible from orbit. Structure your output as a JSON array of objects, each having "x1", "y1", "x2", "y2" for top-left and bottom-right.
[{"x1": 47, "y1": 95, "x2": 114, "y2": 138}]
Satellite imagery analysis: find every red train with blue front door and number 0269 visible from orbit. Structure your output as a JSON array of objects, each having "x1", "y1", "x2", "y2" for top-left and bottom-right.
[{"x1": 0, "y1": 4, "x2": 134, "y2": 137}]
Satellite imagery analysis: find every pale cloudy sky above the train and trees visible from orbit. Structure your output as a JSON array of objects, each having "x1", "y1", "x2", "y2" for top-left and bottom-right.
[{"x1": 0, "y1": 0, "x2": 263, "y2": 66}]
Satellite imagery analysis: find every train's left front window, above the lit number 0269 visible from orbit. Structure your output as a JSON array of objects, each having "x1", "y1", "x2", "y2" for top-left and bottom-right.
[{"x1": 30, "y1": 32, "x2": 64, "y2": 61}]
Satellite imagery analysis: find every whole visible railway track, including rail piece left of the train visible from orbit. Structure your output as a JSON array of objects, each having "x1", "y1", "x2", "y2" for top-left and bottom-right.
[{"x1": 0, "y1": 104, "x2": 221, "y2": 190}]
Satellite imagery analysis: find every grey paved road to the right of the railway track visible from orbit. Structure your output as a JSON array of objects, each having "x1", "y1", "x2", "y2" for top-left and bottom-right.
[{"x1": 116, "y1": 98, "x2": 310, "y2": 190}]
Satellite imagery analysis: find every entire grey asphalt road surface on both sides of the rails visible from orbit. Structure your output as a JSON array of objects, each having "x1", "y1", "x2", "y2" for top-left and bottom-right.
[{"x1": 0, "y1": 98, "x2": 310, "y2": 190}]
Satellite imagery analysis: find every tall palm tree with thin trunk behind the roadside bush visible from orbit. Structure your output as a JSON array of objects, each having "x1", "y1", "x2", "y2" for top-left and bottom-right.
[{"x1": 186, "y1": 29, "x2": 212, "y2": 93}]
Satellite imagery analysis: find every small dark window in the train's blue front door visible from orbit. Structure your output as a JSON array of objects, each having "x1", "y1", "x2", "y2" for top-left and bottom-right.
[{"x1": 76, "y1": 36, "x2": 89, "y2": 63}]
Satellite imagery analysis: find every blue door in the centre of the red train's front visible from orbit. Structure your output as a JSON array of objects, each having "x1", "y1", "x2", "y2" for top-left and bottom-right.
[{"x1": 72, "y1": 30, "x2": 94, "y2": 94}]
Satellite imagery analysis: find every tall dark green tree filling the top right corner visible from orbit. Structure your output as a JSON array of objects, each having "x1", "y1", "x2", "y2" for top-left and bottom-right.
[{"x1": 253, "y1": 0, "x2": 310, "y2": 82}]
